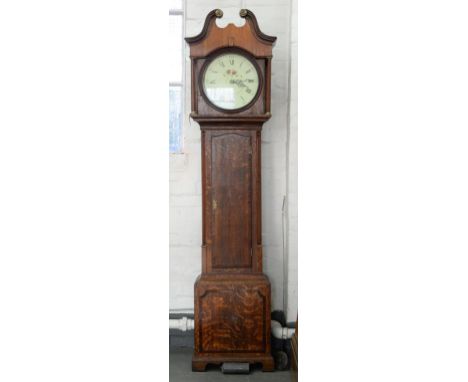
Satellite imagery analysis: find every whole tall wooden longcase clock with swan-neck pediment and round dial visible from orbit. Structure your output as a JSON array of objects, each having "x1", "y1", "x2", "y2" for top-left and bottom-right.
[{"x1": 185, "y1": 9, "x2": 276, "y2": 371}]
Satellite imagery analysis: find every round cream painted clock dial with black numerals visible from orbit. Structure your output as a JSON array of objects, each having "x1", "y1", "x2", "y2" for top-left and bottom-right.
[{"x1": 203, "y1": 53, "x2": 260, "y2": 110}]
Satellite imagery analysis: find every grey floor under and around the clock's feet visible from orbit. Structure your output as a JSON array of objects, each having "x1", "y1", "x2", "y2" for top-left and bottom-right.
[{"x1": 169, "y1": 348, "x2": 291, "y2": 382}]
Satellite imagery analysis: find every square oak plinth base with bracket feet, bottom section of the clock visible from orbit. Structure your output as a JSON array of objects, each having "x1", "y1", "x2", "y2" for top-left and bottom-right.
[{"x1": 192, "y1": 273, "x2": 274, "y2": 371}]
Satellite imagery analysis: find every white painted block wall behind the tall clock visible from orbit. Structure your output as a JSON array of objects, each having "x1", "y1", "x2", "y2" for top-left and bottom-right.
[{"x1": 169, "y1": 0, "x2": 297, "y2": 321}]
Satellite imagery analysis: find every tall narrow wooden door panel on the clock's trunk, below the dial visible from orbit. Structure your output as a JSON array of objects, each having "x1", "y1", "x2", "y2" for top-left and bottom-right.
[{"x1": 210, "y1": 132, "x2": 252, "y2": 268}]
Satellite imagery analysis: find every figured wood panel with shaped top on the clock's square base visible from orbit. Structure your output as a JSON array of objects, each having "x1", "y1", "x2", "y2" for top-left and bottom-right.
[{"x1": 200, "y1": 285, "x2": 266, "y2": 353}]
